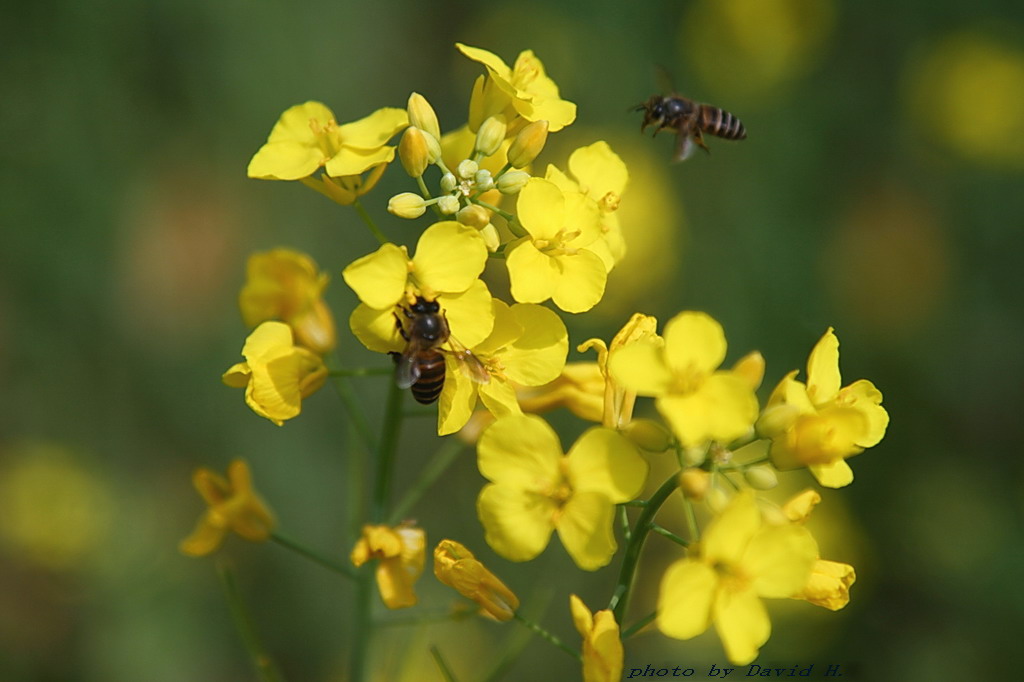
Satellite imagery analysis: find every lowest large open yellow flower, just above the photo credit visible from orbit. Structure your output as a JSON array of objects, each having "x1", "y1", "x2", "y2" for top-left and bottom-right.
[{"x1": 657, "y1": 493, "x2": 817, "y2": 666}]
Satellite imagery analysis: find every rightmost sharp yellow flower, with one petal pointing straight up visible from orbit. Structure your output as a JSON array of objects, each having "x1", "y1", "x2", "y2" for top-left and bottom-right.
[{"x1": 758, "y1": 327, "x2": 889, "y2": 487}]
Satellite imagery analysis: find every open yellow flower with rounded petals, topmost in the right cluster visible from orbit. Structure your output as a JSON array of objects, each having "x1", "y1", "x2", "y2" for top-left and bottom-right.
[{"x1": 608, "y1": 311, "x2": 758, "y2": 447}]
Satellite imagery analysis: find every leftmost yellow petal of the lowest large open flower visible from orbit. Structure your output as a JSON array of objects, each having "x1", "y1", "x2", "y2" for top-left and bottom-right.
[{"x1": 657, "y1": 559, "x2": 719, "y2": 639}]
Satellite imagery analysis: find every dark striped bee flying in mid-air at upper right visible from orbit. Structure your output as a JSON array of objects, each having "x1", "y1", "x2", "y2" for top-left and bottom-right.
[{"x1": 633, "y1": 94, "x2": 746, "y2": 161}]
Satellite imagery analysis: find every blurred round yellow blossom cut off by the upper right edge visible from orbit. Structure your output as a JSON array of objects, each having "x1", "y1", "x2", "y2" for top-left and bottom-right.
[{"x1": 907, "y1": 32, "x2": 1024, "y2": 168}]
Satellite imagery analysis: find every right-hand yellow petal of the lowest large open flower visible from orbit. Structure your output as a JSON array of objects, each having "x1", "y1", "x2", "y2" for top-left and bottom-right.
[{"x1": 739, "y1": 524, "x2": 818, "y2": 598}]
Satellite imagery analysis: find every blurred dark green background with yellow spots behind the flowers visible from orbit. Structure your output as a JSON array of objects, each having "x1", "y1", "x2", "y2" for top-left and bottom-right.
[{"x1": 0, "y1": 0, "x2": 1024, "y2": 682}]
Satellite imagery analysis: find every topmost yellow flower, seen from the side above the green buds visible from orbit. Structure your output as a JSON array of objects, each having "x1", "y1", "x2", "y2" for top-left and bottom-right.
[{"x1": 456, "y1": 43, "x2": 575, "y2": 132}]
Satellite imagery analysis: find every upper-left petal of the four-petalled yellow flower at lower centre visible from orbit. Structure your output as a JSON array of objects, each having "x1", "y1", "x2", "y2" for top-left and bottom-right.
[{"x1": 476, "y1": 415, "x2": 562, "y2": 485}]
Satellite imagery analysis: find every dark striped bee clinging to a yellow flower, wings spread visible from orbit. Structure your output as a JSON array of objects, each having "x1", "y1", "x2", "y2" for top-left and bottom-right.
[{"x1": 392, "y1": 296, "x2": 490, "y2": 404}]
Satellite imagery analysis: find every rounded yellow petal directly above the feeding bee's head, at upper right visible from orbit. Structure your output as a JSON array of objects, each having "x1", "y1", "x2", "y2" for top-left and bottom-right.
[{"x1": 413, "y1": 220, "x2": 489, "y2": 290}]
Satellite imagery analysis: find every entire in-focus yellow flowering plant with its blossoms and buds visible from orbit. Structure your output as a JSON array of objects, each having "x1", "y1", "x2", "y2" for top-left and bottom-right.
[{"x1": 182, "y1": 44, "x2": 888, "y2": 680}]
